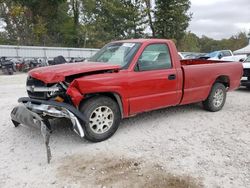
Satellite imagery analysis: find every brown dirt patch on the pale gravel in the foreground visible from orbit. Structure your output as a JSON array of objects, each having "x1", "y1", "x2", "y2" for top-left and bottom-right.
[{"x1": 57, "y1": 154, "x2": 203, "y2": 188}]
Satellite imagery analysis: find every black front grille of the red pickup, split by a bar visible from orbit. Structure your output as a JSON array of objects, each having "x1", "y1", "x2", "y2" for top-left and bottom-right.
[{"x1": 26, "y1": 76, "x2": 47, "y2": 99}]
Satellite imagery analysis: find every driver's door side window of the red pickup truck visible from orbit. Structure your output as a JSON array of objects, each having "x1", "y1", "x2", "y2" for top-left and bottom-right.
[{"x1": 137, "y1": 44, "x2": 172, "y2": 71}]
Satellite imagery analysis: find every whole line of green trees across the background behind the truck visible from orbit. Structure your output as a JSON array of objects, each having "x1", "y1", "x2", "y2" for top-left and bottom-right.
[{"x1": 0, "y1": 0, "x2": 247, "y2": 52}]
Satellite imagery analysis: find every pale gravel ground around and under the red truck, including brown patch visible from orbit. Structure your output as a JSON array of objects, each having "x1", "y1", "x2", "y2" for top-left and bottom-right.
[{"x1": 0, "y1": 74, "x2": 250, "y2": 188}]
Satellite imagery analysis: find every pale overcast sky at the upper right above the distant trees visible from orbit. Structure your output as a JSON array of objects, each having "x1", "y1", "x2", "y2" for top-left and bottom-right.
[{"x1": 188, "y1": 0, "x2": 250, "y2": 39}]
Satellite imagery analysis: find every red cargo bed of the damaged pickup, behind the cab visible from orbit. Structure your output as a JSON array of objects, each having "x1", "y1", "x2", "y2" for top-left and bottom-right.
[{"x1": 181, "y1": 59, "x2": 242, "y2": 104}]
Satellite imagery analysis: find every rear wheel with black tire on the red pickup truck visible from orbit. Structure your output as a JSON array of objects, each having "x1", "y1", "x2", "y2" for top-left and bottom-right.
[{"x1": 203, "y1": 83, "x2": 227, "y2": 112}]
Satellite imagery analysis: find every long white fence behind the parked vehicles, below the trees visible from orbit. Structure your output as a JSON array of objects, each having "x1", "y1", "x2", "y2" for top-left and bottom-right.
[{"x1": 0, "y1": 45, "x2": 98, "y2": 59}]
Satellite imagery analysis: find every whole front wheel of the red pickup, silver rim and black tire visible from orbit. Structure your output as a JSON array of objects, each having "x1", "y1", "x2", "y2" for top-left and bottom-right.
[{"x1": 80, "y1": 96, "x2": 121, "y2": 142}]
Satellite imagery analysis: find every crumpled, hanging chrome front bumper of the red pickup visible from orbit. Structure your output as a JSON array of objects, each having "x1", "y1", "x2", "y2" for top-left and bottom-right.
[{"x1": 11, "y1": 97, "x2": 86, "y2": 137}]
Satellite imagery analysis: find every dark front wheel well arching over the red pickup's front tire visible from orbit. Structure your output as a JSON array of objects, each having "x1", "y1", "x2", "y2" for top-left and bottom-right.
[{"x1": 80, "y1": 92, "x2": 123, "y2": 117}]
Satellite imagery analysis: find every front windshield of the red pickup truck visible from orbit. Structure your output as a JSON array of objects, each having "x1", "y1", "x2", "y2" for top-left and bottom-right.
[{"x1": 89, "y1": 42, "x2": 140, "y2": 68}]
